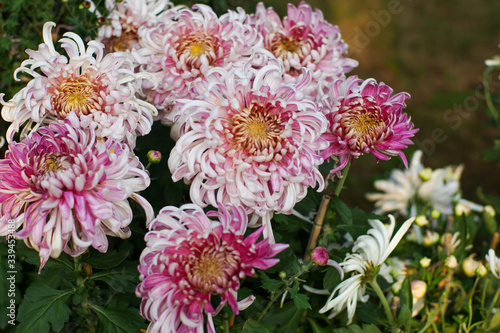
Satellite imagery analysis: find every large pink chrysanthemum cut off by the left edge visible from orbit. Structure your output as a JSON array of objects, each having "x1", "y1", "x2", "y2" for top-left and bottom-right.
[{"x1": 0, "y1": 120, "x2": 154, "y2": 269}]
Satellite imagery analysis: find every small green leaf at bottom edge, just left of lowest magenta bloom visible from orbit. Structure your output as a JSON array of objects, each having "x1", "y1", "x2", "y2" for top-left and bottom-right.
[{"x1": 90, "y1": 304, "x2": 145, "y2": 333}]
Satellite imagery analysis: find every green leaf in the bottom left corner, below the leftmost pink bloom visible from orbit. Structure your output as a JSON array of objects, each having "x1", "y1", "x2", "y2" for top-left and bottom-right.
[{"x1": 17, "y1": 284, "x2": 74, "y2": 333}]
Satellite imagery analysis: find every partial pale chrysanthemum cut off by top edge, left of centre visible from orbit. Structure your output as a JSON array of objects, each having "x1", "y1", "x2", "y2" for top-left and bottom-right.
[{"x1": 97, "y1": 0, "x2": 173, "y2": 52}]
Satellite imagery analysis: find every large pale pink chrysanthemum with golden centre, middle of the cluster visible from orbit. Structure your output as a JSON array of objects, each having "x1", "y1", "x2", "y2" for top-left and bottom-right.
[{"x1": 168, "y1": 60, "x2": 328, "y2": 237}]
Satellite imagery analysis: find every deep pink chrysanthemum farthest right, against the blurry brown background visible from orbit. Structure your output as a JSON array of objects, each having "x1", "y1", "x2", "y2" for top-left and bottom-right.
[{"x1": 321, "y1": 76, "x2": 418, "y2": 173}]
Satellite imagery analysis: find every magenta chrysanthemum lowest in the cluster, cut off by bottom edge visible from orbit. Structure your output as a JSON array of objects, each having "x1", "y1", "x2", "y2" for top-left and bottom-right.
[{"x1": 136, "y1": 204, "x2": 288, "y2": 332}]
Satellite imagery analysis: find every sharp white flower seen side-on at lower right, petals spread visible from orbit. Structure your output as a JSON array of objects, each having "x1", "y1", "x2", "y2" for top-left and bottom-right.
[{"x1": 319, "y1": 215, "x2": 414, "y2": 324}]
